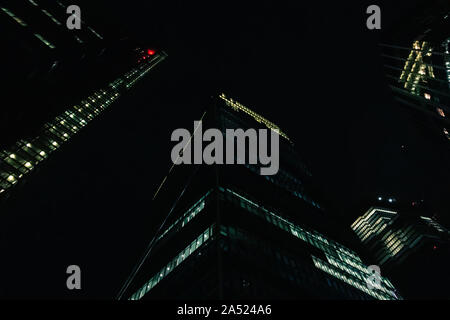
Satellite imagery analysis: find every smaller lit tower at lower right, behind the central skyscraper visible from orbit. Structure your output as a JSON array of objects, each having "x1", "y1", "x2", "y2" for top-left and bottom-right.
[{"x1": 351, "y1": 207, "x2": 450, "y2": 299}]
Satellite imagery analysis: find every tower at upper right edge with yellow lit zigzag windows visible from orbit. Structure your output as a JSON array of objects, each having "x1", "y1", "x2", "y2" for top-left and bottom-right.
[{"x1": 380, "y1": 0, "x2": 450, "y2": 146}]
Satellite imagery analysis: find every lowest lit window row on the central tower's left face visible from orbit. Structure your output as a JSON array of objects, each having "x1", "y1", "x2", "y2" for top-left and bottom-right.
[{"x1": 130, "y1": 225, "x2": 214, "y2": 300}]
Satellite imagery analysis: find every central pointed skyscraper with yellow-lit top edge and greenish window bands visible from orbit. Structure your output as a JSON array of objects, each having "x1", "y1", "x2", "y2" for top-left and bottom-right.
[{"x1": 118, "y1": 94, "x2": 401, "y2": 300}]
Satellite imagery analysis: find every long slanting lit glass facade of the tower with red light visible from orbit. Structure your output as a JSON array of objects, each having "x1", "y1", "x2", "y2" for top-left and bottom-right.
[{"x1": 0, "y1": 53, "x2": 166, "y2": 195}]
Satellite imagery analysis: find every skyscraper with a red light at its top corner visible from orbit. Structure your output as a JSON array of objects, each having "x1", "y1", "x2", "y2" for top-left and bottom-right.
[{"x1": 0, "y1": 0, "x2": 166, "y2": 199}]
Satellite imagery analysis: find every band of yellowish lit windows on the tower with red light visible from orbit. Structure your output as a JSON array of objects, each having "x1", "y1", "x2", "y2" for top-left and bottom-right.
[{"x1": 0, "y1": 58, "x2": 164, "y2": 194}]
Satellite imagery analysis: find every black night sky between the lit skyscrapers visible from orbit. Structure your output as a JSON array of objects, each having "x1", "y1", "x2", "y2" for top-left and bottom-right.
[{"x1": 0, "y1": 0, "x2": 449, "y2": 298}]
